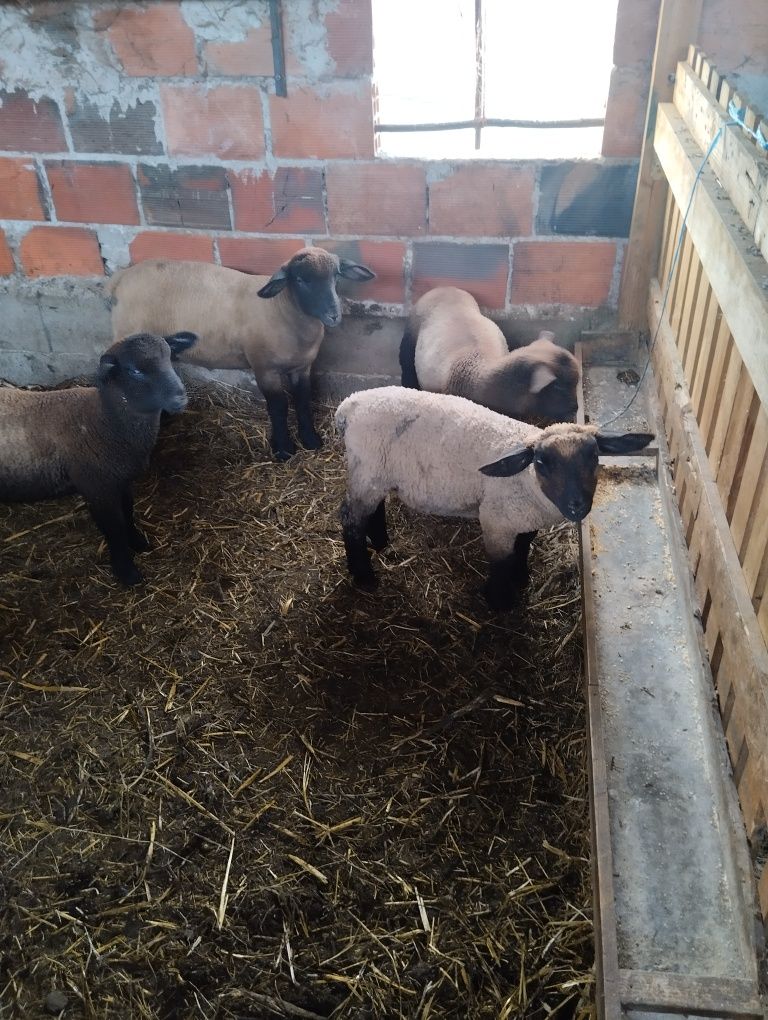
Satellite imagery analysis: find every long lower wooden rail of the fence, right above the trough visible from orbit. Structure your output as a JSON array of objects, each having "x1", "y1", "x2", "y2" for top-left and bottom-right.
[{"x1": 649, "y1": 281, "x2": 768, "y2": 918}]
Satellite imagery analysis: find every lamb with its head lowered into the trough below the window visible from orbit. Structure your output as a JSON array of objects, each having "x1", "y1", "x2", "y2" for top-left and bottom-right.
[{"x1": 400, "y1": 287, "x2": 578, "y2": 425}]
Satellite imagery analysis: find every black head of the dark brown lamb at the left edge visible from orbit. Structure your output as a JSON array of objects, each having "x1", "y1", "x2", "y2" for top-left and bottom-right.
[{"x1": 99, "y1": 333, "x2": 197, "y2": 414}]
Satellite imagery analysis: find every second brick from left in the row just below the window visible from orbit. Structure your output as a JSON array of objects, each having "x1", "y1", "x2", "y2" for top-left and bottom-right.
[{"x1": 45, "y1": 160, "x2": 139, "y2": 223}]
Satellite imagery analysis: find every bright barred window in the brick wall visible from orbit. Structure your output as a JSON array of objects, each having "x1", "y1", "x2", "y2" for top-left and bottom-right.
[{"x1": 373, "y1": 0, "x2": 617, "y2": 159}]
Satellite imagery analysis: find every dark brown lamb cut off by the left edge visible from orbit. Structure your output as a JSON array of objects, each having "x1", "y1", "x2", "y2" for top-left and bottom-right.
[{"x1": 0, "y1": 333, "x2": 197, "y2": 584}]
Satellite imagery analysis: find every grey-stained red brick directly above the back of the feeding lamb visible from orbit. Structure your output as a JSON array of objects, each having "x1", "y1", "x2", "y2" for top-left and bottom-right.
[{"x1": 413, "y1": 241, "x2": 509, "y2": 308}]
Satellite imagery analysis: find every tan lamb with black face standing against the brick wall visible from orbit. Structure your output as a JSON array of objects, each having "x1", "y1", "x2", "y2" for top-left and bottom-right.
[{"x1": 109, "y1": 248, "x2": 374, "y2": 461}]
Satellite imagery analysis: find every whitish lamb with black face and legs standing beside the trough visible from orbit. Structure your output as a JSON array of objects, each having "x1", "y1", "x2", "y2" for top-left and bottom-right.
[{"x1": 336, "y1": 387, "x2": 653, "y2": 609}]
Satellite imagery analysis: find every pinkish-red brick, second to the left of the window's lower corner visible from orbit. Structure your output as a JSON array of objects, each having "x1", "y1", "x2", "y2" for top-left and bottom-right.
[{"x1": 160, "y1": 85, "x2": 264, "y2": 159}]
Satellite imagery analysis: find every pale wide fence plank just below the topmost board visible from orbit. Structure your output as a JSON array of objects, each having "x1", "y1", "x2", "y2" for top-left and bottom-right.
[{"x1": 655, "y1": 103, "x2": 768, "y2": 407}]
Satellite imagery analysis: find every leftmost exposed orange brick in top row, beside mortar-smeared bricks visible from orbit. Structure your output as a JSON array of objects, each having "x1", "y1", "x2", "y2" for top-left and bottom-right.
[{"x1": 94, "y1": 0, "x2": 198, "y2": 77}]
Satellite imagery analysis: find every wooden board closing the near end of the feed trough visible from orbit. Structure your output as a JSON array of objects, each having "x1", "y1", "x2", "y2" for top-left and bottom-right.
[{"x1": 617, "y1": 970, "x2": 765, "y2": 1020}]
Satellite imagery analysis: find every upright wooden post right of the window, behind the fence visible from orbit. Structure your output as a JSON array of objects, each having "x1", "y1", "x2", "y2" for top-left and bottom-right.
[{"x1": 618, "y1": 0, "x2": 703, "y2": 329}]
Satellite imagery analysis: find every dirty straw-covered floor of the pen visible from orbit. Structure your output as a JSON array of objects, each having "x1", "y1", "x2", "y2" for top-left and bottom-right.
[{"x1": 0, "y1": 398, "x2": 594, "y2": 1020}]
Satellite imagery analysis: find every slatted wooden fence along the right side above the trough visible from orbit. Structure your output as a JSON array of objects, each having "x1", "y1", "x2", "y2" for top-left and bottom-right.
[{"x1": 649, "y1": 48, "x2": 768, "y2": 919}]
